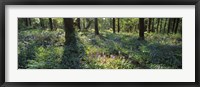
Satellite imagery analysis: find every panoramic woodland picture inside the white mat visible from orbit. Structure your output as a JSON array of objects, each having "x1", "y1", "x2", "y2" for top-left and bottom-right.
[{"x1": 18, "y1": 17, "x2": 182, "y2": 69}]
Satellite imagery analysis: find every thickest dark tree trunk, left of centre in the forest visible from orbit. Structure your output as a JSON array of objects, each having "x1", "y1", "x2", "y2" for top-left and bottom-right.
[{"x1": 63, "y1": 18, "x2": 76, "y2": 45}]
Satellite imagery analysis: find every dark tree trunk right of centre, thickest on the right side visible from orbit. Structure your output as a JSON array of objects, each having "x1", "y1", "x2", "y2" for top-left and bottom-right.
[{"x1": 139, "y1": 18, "x2": 145, "y2": 40}]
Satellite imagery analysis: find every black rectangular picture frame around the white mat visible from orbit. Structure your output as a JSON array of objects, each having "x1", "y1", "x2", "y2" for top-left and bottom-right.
[{"x1": 0, "y1": 0, "x2": 200, "y2": 87}]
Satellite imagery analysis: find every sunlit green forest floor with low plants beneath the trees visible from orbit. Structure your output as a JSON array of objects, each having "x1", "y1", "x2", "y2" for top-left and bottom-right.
[{"x1": 18, "y1": 29, "x2": 182, "y2": 69}]
